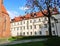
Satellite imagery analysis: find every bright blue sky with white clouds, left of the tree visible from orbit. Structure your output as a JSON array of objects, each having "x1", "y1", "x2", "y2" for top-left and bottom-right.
[{"x1": 3, "y1": 0, "x2": 28, "y2": 19}]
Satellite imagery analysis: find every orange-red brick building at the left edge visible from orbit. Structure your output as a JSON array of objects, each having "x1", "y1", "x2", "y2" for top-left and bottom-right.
[{"x1": 0, "y1": 0, "x2": 11, "y2": 38}]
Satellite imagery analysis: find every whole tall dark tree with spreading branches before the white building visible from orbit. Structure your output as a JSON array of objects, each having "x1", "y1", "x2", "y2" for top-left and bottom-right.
[{"x1": 26, "y1": 0, "x2": 60, "y2": 37}]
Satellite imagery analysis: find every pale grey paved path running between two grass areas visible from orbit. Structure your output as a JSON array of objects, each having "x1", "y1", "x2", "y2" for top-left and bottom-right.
[{"x1": 0, "y1": 39, "x2": 47, "y2": 46}]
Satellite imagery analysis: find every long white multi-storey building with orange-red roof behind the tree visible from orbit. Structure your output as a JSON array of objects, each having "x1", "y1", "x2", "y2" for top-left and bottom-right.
[{"x1": 11, "y1": 12, "x2": 60, "y2": 36}]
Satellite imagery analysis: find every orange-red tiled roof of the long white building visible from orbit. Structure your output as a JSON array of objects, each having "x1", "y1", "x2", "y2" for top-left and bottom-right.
[{"x1": 13, "y1": 7, "x2": 58, "y2": 22}]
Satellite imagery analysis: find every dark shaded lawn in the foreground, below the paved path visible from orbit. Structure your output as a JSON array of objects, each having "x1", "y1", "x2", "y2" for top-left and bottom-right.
[{"x1": 7, "y1": 37, "x2": 60, "y2": 46}]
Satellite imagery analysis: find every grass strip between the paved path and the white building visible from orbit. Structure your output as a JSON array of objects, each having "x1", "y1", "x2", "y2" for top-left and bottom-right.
[{"x1": 8, "y1": 36, "x2": 47, "y2": 41}]
